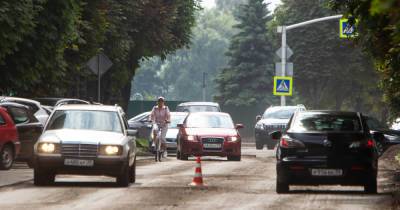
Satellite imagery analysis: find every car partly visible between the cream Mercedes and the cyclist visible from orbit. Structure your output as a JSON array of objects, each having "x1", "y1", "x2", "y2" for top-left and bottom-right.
[{"x1": 128, "y1": 112, "x2": 152, "y2": 141}]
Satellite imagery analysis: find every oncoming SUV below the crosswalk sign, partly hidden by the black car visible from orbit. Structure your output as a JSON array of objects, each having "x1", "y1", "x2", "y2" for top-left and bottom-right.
[{"x1": 254, "y1": 105, "x2": 306, "y2": 149}]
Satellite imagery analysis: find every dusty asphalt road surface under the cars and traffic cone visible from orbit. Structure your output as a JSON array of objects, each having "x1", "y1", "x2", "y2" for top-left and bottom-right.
[{"x1": 0, "y1": 147, "x2": 392, "y2": 210}]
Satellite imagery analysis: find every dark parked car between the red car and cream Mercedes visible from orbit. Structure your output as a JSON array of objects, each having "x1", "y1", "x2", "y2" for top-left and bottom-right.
[{"x1": 0, "y1": 102, "x2": 43, "y2": 167}]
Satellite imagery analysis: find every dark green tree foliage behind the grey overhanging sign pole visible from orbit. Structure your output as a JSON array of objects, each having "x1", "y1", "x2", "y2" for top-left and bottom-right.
[{"x1": 275, "y1": 0, "x2": 383, "y2": 116}]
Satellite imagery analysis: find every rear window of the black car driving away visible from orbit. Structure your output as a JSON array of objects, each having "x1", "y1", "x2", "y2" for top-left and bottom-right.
[{"x1": 290, "y1": 113, "x2": 362, "y2": 132}]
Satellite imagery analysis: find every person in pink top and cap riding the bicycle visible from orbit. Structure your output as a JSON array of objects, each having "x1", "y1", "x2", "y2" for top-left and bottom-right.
[{"x1": 150, "y1": 96, "x2": 171, "y2": 157}]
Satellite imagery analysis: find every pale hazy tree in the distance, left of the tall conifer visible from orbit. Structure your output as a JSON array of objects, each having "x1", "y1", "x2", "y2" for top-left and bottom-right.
[{"x1": 132, "y1": 8, "x2": 235, "y2": 100}]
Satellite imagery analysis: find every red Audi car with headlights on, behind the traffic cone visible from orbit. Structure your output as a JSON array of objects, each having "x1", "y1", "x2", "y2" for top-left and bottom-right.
[{"x1": 176, "y1": 112, "x2": 243, "y2": 161}]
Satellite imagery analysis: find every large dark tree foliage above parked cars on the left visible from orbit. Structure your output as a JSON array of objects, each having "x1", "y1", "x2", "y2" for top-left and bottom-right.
[{"x1": 0, "y1": 0, "x2": 199, "y2": 106}]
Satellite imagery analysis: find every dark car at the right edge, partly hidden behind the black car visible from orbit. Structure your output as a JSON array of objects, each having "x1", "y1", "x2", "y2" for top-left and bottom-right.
[{"x1": 366, "y1": 117, "x2": 400, "y2": 155}]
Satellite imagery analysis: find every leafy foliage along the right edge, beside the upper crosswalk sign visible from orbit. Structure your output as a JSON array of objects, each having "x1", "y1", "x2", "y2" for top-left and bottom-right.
[{"x1": 330, "y1": 0, "x2": 400, "y2": 117}]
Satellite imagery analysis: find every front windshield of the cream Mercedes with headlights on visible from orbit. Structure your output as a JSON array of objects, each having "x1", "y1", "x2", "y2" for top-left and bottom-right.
[{"x1": 46, "y1": 110, "x2": 122, "y2": 133}]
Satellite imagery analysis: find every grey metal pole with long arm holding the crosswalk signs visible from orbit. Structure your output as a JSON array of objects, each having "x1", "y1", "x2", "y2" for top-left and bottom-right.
[{"x1": 278, "y1": 15, "x2": 343, "y2": 106}]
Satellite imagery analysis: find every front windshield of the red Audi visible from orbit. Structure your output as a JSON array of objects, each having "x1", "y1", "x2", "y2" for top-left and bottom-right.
[{"x1": 186, "y1": 114, "x2": 234, "y2": 129}]
